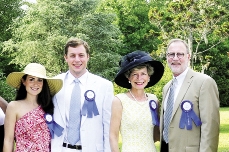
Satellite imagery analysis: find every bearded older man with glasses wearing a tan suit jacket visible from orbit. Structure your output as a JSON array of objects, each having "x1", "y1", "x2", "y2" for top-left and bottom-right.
[{"x1": 160, "y1": 39, "x2": 220, "y2": 152}]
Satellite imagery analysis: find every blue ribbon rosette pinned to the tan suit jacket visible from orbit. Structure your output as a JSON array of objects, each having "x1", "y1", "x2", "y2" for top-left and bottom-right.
[{"x1": 179, "y1": 100, "x2": 202, "y2": 130}]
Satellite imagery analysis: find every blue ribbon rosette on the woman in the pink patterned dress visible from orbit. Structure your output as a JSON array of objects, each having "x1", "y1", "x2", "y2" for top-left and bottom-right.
[{"x1": 44, "y1": 114, "x2": 64, "y2": 139}]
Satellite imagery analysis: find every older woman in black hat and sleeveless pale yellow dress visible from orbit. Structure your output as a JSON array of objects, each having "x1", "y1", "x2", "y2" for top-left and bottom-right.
[{"x1": 110, "y1": 51, "x2": 164, "y2": 152}]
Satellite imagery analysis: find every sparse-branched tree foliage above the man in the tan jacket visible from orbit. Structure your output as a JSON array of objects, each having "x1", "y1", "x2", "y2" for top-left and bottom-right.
[{"x1": 148, "y1": 0, "x2": 229, "y2": 67}]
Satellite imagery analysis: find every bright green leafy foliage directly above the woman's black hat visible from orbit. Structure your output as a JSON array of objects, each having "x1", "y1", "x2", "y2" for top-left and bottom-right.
[{"x1": 99, "y1": 0, "x2": 161, "y2": 55}]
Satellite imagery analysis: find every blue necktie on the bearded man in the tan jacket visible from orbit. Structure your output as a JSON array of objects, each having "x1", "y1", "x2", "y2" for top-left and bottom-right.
[{"x1": 163, "y1": 78, "x2": 177, "y2": 143}]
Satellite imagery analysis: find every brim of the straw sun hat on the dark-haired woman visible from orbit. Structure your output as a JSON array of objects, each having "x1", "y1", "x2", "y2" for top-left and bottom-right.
[{"x1": 6, "y1": 72, "x2": 63, "y2": 96}]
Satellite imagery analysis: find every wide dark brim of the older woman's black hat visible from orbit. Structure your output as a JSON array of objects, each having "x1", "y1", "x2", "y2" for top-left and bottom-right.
[{"x1": 115, "y1": 60, "x2": 164, "y2": 89}]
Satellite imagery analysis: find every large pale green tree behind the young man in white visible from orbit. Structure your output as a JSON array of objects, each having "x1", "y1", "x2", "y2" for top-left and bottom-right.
[{"x1": 3, "y1": 0, "x2": 122, "y2": 79}]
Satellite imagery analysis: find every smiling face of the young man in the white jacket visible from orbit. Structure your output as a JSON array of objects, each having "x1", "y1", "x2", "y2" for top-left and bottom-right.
[{"x1": 64, "y1": 45, "x2": 89, "y2": 78}]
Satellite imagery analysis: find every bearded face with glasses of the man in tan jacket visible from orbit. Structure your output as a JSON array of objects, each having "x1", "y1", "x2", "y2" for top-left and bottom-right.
[{"x1": 166, "y1": 41, "x2": 190, "y2": 77}]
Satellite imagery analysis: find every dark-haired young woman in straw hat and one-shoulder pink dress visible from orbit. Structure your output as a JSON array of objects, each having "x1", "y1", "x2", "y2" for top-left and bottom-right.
[{"x1": 3, "y1": 63, "x2": 62, "y2": 152}]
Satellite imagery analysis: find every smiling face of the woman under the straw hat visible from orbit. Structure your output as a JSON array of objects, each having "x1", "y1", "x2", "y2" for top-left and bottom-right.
[{"x1": 22, "y1": 75, "x2": 43, "y2": 96}]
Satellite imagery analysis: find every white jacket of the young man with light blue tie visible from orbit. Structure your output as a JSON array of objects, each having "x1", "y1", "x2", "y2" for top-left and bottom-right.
[{"x1": 51, "y1": 71, "x2": 114, "y2": 152}]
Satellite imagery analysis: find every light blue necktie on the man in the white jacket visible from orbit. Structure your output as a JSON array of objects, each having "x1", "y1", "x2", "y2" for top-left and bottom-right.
[{"x1": 68, "y1": 79, "x2": 81, "y2": 145}]
